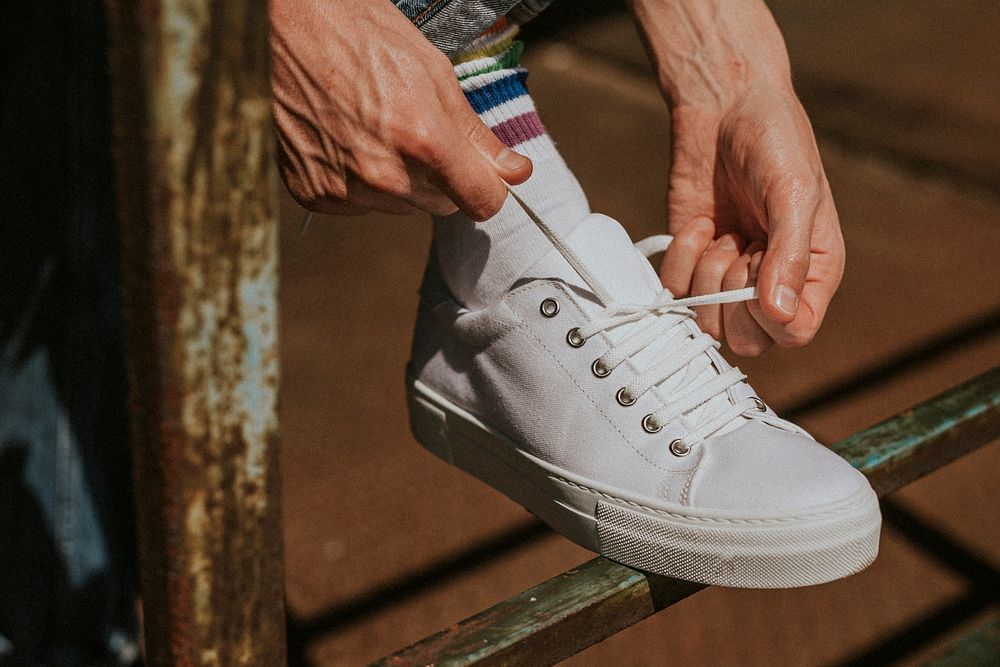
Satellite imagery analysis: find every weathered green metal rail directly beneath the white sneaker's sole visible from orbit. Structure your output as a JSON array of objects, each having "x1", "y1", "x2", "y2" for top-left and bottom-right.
[{"x1": 375, "y1": 367, "x2": 1000, "y2": 665}]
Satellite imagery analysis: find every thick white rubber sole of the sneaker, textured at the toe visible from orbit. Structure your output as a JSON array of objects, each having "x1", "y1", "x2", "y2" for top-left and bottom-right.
[{"x1": 407, "y1": 379, "x2": 881, "y2": 588}]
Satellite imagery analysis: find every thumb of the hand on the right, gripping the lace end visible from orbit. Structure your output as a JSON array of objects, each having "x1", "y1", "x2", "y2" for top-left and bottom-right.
[{"x1": 757, "y1": 189, "x2": 816, "y2": 324}]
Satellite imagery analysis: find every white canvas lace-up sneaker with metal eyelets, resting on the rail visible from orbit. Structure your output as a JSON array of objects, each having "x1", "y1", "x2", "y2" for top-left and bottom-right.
[{"x1": 407, "y1": 188, "x2": 881, "y2": 588}]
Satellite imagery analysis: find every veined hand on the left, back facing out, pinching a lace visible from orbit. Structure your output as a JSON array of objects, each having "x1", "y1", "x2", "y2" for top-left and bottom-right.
[{"x1": 268, "y1": 0, "x2": 531, "y2": 220}]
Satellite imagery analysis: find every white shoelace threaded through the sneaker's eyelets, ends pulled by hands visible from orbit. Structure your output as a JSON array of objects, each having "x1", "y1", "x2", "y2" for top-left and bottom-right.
[{"x1": 507, "y1": 185, "x2": 766, "y2": 456}]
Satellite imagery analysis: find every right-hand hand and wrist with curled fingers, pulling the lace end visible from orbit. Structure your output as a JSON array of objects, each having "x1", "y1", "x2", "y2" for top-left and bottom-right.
[{"x1": 632, "y1": 0, "x2": 844, "y2": 356}]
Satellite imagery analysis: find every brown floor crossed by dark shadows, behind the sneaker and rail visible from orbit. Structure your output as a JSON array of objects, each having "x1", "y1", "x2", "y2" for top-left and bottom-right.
[{"x1": 281, "y1": 2, "x2": 1000, "y2": 665}]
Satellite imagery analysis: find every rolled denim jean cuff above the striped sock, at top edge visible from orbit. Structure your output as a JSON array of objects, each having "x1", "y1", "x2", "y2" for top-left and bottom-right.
[{"x1": 393, "y1": 0, "x2": 552, "y2": 58}]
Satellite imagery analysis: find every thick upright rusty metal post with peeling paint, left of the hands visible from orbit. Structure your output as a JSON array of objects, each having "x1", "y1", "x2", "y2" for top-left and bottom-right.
[{"x1": 109, "y1": 0, "x2": 285, "y2": 665}]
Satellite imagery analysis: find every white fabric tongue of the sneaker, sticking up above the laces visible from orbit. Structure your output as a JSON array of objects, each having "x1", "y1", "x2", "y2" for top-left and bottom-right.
[{"x1": 525, "y1": 213, "x2": 663, "y2": 310}]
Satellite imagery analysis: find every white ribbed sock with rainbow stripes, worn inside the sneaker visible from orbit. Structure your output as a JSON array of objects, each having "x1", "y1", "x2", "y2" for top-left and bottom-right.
[{"x1": 434, "y1": 19, "x2": 590, "y2": 308}]
